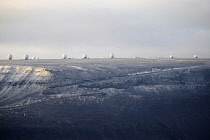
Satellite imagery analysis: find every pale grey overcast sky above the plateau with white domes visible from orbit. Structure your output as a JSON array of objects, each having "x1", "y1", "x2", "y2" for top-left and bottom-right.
[{"x1": 0, "y1": 0, "x2": 210, "y2": 59}]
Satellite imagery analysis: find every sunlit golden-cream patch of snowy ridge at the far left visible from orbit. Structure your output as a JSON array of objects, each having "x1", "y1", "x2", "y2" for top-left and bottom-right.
[{"x1": 0, "y1": 66, "x2": 53, "y2": 77}]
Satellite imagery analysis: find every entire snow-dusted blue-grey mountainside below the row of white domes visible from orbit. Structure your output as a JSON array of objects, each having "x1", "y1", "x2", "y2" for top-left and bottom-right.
[{"x1": 0, "y1": 59, "x2": 210, "y2": 140}]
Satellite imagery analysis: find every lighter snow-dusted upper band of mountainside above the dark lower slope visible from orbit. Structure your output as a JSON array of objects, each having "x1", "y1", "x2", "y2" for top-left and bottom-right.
[{"x1": 0, "y1": 60, "x2": 209, "y2": 108}]
